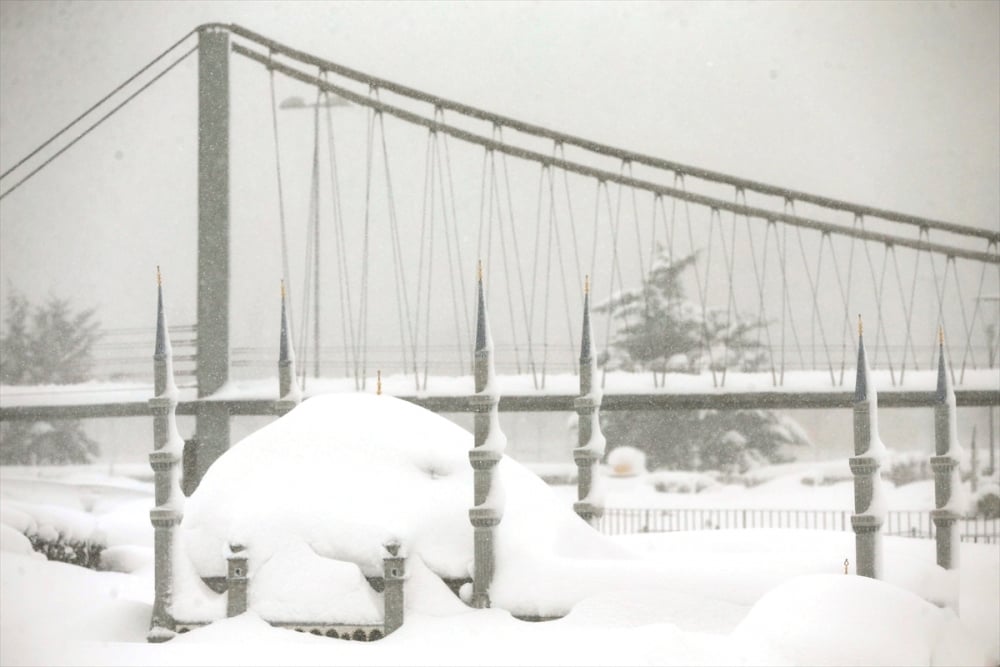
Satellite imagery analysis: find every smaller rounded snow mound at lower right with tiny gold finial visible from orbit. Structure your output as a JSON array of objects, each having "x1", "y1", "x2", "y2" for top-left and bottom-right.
[{"x1": 734, "y1": 574, "x2": 989, "y2": 665}]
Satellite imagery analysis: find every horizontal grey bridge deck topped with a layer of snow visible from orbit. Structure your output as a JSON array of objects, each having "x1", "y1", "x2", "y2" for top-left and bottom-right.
[{"x1": 0, "y1": 369, "x2": 1000, "y2": 420}]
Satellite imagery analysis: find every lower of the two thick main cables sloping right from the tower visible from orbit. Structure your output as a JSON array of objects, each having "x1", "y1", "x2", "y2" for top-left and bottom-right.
[{"x1": 233, "y1": 44, "x2": 1000, "y2": 264}]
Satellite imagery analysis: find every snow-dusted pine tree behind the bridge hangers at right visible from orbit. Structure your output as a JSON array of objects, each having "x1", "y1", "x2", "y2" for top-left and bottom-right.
[{"x1": 594, "y1": 248, "x2": 809, "y2": 473}]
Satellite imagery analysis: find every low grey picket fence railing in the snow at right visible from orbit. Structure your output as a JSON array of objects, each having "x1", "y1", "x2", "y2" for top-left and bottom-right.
[{"x1": 600, "y1": 507, "x2": 1000, "y2": 544}]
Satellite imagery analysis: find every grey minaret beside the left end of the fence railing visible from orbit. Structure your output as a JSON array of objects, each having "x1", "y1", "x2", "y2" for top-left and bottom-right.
[{"x1": 573, "y1": 276, "x2": 606, "y2": 526}]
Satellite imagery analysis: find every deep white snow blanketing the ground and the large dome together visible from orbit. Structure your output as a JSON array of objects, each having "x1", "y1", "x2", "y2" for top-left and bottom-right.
[{"x1": 0, "y1": 395, "x2": 1000, "y2": 665}]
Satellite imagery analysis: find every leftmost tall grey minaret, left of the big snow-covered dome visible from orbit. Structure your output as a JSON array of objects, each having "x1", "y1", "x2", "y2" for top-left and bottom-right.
[{"x1": 147, "y1": 267, "x2": 184, "y2": 642}]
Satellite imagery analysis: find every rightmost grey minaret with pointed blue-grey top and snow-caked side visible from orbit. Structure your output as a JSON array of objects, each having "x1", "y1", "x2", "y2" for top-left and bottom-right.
[{"x1": 931, "y1": 329, "x2": 961, "y2": 570}]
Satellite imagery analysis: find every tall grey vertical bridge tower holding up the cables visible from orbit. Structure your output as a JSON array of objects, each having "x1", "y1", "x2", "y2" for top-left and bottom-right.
[{"x1": 192, "y1": 26, "x2": 229, "y2": 488}]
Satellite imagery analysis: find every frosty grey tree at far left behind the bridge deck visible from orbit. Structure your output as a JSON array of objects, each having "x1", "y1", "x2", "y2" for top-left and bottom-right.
[{"x1": 0, "y1": 291, "x2": 100, "y2": 465}]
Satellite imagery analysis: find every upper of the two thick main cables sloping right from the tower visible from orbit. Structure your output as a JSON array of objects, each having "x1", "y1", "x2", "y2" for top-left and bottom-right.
[{"x1": 223, "y1": 24, "x2": 1000, "y2": 248}]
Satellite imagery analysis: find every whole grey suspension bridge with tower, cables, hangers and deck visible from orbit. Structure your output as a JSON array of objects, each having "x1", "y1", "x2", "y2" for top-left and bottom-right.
[{"x1": 0, "y1": 24, "x2": 1000, "y2": 440}]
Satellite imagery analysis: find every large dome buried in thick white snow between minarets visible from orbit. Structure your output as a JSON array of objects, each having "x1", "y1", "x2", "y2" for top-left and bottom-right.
[{"x1": 179, "y1": 393, "x2": 620, "y2": 620}]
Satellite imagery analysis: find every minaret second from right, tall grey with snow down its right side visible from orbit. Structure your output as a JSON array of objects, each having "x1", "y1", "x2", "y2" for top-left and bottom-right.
[{"x1": 850, "y1": 315, "x2": 885, "y2": 579}]
